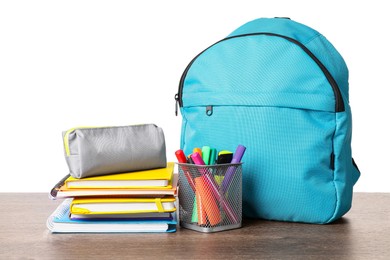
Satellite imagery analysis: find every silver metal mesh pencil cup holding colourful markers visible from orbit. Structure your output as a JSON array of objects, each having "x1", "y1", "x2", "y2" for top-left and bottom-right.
[{"x1": 178, "y1": 163, "x2": 242, "y2": 232}]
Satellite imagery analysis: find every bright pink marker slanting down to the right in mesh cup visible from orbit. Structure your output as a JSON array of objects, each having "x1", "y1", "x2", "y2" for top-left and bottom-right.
[{"x1": 191, "y1": 153, "x2": 239, "y2": 223}]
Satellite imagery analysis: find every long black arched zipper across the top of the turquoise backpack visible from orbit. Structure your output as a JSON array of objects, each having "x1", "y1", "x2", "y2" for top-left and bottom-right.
[{"x1": 175, "y1": 32, "x2": 345, "y2": 116}]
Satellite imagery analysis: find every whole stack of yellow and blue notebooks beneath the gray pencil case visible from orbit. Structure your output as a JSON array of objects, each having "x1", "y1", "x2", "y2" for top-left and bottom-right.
[{"x1": 47, "y1": 162, "x2": 178, "y2": 233}]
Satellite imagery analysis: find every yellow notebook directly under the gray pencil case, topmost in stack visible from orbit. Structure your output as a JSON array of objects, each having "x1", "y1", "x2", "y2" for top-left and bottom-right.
[{"x1": 64, "y1": 162, "x2": 174, "y2": 189}]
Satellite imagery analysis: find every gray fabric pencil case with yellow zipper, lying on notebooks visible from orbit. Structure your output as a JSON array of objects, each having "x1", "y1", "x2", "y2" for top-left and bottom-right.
[{"x1": 63, "y1": 124, "x2": 167, "y2": 178}]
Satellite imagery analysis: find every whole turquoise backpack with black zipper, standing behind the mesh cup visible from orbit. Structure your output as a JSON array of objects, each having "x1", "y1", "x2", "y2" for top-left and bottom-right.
[{"x1": 175, "y1": 18, "x2": 360, "y2": 223}]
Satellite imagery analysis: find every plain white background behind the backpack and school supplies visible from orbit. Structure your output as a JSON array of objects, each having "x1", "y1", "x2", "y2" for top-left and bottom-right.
[{"x1": 0, "y1": 0, "x2": 390, "y2": 192}]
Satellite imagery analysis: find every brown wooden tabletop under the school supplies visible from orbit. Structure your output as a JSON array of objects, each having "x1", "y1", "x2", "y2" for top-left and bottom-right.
[{"x1": 0, "y1": 193, "x2": 390, "y2": 259}]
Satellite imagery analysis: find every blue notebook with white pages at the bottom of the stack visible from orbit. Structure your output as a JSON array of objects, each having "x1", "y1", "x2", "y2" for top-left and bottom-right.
[{"x1": 46, "y1": 199, "x2": 177, "y2": 233}]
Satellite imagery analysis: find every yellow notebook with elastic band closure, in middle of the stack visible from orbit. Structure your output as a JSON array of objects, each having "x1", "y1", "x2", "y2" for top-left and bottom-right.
[{"x1": 70, "y1": 196, "x2": 176, "y2": 214}]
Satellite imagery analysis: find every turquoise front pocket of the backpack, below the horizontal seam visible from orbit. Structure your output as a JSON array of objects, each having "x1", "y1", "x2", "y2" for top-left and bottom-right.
[{"x1": 182, "y1": 106, "x2": 337, "y2": 223}]
